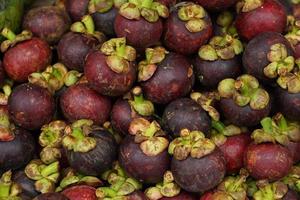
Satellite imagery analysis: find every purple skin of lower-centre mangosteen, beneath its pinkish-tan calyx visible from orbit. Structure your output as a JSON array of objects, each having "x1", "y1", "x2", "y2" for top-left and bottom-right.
[{"x1": 118, "y1": 135, "x2": 170, "y2": 184}]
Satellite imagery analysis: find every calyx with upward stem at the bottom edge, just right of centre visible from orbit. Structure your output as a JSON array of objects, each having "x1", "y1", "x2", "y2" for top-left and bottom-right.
[{"x1": 145, "y1": 171, "x2": 181, "y2": 200}]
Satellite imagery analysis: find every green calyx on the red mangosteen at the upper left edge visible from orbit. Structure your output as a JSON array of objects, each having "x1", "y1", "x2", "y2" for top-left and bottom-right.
[{"x1": 1, "y1": 28, "x2": 32, "y2": 53}]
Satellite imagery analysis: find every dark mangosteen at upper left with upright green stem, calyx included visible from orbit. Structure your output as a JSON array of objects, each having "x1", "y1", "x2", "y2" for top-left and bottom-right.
[{"x1": 57, "y1": 15, "x2": 105, "y2": 72}]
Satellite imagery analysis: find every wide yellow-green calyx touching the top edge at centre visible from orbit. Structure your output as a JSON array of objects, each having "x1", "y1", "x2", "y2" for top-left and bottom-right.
[{"x1": 119, "y1": 0, "x2": 169, "y2": 23}]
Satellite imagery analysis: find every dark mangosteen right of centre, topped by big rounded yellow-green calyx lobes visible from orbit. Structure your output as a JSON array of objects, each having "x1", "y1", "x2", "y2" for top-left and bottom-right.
[{"x1": 218, "y1": 74, "x2": 271, "y2": 127}]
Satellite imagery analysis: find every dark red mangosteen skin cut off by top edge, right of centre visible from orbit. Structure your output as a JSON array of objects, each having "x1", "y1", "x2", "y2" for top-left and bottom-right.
[{"x1": 194, "y1": 0, "x2": 238, "y2": 11}]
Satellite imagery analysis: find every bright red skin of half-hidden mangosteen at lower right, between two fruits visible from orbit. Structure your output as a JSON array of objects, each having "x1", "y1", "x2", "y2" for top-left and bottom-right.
[{"x1": 219, "y1": 133, "x2": 251, "y2": 174}]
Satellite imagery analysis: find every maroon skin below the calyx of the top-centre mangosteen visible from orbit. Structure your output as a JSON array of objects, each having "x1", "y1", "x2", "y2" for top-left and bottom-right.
[{"x1": 114, "y1": 14, "x2": 163, "y2": 49}]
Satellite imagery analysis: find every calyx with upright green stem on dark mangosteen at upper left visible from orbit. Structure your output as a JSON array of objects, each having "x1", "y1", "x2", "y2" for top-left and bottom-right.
[{"x1": 71, "y1": 15, "x2": 105, "y2": 42}]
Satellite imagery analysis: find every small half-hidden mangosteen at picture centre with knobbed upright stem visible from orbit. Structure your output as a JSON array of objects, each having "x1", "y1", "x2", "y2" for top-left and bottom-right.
[{"x1": 110, "y1": 86, "x2": 154, "y2": 135}]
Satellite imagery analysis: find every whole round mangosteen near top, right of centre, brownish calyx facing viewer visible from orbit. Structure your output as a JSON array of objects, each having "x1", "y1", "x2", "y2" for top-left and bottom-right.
[{"x1": 163, "y1": 2, "x2": 213, "y2": 55}]
